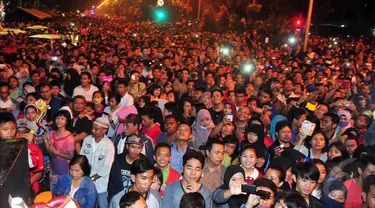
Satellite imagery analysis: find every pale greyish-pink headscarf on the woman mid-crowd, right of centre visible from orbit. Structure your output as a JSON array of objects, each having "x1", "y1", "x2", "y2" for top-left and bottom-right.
[{"x1": 192, "y1": 109, "x2": 214, "y2": 148}]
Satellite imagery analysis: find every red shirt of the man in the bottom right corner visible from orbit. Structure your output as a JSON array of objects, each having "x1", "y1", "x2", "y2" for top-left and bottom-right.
[{"x1": 344, "y1": 179, "x2": 362, "y2": 208}]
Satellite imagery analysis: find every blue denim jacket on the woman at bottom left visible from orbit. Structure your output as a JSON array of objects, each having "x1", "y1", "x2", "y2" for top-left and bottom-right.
[{"x1": 52, "y1": 174, "x2": 97, "y2": 208}]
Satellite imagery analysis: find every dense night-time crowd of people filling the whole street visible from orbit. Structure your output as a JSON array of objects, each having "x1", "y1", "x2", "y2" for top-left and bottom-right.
[{"x1": 0, "y1": 18, "x2": 375, "y2": 208}]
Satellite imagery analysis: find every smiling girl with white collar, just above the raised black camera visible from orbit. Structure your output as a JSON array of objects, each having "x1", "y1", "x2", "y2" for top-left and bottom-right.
[{"x1": 240, "y1": 144, "x2": 263, "y2": 184}]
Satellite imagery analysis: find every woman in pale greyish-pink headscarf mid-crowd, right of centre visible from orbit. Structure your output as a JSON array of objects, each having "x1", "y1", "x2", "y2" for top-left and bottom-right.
[{"x1": 192, "y1": 109, "x2": 215, "y2": 149}]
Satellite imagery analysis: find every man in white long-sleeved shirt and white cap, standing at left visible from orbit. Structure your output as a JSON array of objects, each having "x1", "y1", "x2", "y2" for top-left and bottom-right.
[{"x1": 80, "y1": 117, "x2": 115, "y2": 208}]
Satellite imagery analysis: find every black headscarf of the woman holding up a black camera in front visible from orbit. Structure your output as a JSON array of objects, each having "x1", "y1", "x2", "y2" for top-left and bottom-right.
[{"x1": 219, "y1": 165, "x2": 247, "y2": 208}]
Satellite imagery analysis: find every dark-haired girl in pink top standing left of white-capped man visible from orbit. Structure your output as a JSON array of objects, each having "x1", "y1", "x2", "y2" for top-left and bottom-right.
[{"x1": 44, "y1": 110, "x2": 75, "y2": 190}]
